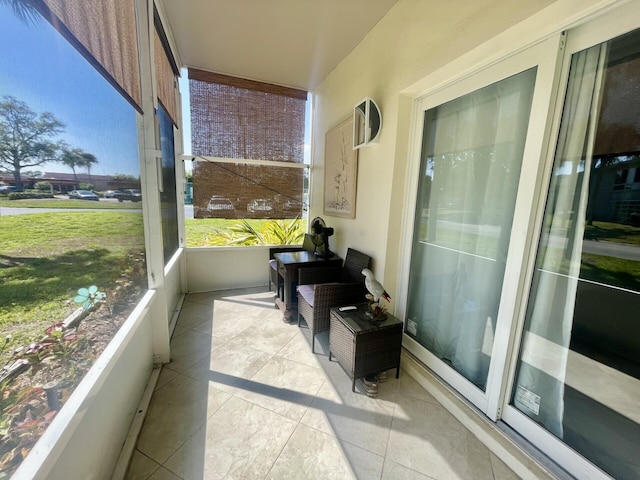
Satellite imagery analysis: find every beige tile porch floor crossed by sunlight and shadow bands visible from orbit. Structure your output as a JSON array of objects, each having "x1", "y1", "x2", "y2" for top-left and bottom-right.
[{"x1": 127, "y1": 289, "x2": 517, "y2": 480}]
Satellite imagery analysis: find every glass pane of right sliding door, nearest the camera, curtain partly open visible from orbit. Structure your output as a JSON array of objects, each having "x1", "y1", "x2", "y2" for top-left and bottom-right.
[{"x1": 505, "y1": 25, "x2": 640, "y2": 478}]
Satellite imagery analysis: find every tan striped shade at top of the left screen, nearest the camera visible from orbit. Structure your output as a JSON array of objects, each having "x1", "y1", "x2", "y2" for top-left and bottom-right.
[{"x1": 33, "y1": 0, "x2": 142, "y2": 112}]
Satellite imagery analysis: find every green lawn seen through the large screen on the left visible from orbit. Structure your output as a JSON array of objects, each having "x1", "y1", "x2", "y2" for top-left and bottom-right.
[{"x1": 0, "y1": 210, "x2": 144, "y2": 352}]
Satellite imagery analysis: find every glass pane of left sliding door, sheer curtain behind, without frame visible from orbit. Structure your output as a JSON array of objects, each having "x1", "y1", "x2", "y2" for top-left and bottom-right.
[{"x1": 407, "y1": 68, "x2": 536, "y2": 390}]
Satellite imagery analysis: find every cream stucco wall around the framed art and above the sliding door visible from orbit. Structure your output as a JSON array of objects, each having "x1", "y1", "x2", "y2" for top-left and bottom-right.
[{"x1": 310, "y1": 0, "x2": 614, "y2": 314}]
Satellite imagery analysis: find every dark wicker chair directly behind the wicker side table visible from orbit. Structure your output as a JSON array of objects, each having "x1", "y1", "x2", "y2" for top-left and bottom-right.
[{"x1": 298, "y1": 248, "x2": 371, "y2": 353}]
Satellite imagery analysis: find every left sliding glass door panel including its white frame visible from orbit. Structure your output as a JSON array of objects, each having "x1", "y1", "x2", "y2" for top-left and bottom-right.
[{"x1": 403, "y1": 39, "x2": 559, "y2": 410}]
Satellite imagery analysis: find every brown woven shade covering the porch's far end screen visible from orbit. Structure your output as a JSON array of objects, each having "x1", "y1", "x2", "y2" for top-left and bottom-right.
[{"x1": 189, "y1": 69, "x2": 307, "y2": 218}]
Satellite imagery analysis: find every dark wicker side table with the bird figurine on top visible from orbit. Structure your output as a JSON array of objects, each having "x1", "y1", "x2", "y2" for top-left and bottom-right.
[{"x1": 329, "y1": 303, "x2": 402, "y2": 392}]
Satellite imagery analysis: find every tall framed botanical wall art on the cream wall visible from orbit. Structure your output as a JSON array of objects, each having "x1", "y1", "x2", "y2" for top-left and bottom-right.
[{"x1": 324, "y1": 117, "x2": 358, "y2": 218}]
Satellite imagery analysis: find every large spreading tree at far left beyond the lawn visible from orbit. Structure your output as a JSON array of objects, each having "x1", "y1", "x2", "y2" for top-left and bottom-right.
[{"x1": 0, "y1": 95, "x2": 64, "y2": 189}]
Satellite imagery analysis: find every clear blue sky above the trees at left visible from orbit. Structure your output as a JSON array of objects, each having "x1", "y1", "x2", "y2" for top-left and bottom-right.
[{"x1": 0, "y1": 4, "x2": 139, "y2": 176}]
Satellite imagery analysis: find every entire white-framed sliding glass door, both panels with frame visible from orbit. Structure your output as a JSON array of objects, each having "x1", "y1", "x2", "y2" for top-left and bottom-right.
[{"x1": 398, "y1": 0, "x2": 640, "y2": 479}]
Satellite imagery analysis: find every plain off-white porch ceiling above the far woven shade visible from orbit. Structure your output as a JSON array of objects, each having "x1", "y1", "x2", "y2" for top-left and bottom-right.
[{"x1": 161, "y1": 0, "x2": 397, "y2": 91}]
